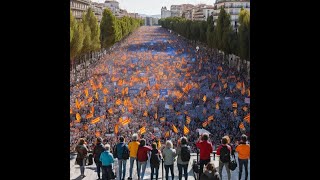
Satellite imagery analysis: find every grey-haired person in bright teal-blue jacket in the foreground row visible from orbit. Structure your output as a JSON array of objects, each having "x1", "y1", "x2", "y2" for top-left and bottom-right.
[{"x1": 99, "y1": 144, "x2": 114, "y2": 180}]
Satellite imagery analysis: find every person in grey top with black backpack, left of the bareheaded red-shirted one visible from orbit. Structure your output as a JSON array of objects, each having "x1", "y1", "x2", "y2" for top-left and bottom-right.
[{"x1": 177, "y1": 137, "x2": 191, "y2": 180}]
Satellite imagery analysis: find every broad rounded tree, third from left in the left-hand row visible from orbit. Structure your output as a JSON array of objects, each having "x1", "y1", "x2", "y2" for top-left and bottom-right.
[{"x1": 100, "y1": 8, "x2": 116, "y2": 48}]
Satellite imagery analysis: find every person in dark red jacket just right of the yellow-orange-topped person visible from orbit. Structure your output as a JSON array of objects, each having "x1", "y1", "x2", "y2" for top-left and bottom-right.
[{"x1": 137, "y1": 139, "x2": 152, "y2": 180}]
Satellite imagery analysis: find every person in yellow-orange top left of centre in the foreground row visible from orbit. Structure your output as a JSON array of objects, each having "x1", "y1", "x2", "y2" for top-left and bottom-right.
[{"x1": 128, "y1": 133, "x2": 140, "y2": 180}]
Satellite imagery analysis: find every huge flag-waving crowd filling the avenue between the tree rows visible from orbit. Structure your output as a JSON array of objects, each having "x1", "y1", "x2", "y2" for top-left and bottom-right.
[{"x1": 70, "y1": 27, "x2": 250, "y2": 179}]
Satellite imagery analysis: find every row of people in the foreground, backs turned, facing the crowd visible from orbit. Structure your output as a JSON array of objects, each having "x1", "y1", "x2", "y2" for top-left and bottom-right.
[{"x1": 76, "y1": 133, "x2": 250, "y2": 180}]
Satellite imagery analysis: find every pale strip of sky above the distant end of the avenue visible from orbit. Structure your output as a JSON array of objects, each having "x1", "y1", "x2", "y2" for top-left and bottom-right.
[{"x1": 92, "y1": 0, "x2": 215, "y2": 15}]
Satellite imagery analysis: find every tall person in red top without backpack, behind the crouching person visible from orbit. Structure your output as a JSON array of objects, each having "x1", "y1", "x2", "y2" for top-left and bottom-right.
[{"x1": 196, "y1": 133, "x2": 213, "y2": 177}]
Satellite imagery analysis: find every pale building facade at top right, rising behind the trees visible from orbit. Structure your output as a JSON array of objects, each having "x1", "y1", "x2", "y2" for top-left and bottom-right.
[{"x1": 213, "y1": 0, "x2": 250, "y2": 28}]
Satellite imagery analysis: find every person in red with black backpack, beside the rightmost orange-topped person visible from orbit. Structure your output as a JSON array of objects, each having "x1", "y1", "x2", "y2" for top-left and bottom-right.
[{"x1": 217, "y1": 136, "x2": 231, "y2": 180}]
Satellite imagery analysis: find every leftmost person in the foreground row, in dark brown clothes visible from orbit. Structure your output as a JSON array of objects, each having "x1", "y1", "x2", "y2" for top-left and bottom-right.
[{"x1": 76, "y1": 138, "x2": 88, "y2": 178}]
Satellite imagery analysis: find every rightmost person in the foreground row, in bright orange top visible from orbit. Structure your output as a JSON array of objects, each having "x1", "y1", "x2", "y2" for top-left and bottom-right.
[{"x1": 236, "y1": 134, "x2": 250, "y2": 180}]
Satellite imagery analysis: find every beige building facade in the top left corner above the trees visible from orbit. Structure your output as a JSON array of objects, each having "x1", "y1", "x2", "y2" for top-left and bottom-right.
[{"x1": 70, "y1": 0, "x2": 91, "y2": 20}]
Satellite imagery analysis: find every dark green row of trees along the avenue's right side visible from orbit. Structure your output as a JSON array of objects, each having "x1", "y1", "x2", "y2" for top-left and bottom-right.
[{"x1": 159, "y1": 8, "x2": 250, "y2": 61}]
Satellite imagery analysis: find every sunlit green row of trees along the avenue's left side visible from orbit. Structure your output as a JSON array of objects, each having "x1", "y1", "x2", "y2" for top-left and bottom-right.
[{"x1": 70, "y1": 8, "x2": 143, "y2": 82}]
